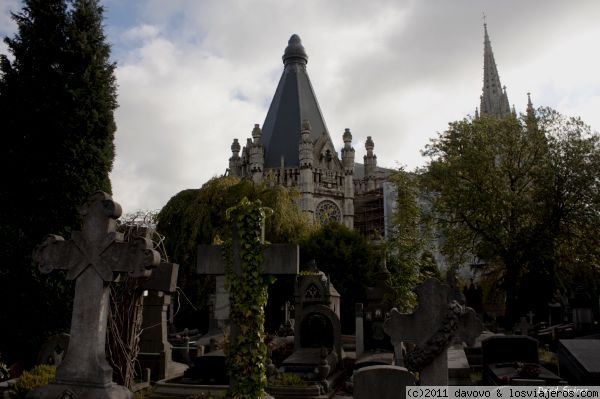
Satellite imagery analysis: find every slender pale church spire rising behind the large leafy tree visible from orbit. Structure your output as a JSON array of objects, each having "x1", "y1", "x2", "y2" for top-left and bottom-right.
[{"x1": 479, "y1": 22, "x2": 510, "y2": 118}]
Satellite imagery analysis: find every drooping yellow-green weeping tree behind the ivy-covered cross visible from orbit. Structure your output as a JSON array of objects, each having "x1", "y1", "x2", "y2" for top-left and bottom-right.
[{"x1": 157, "y1": 176, "x2": 311, "y2": 328}]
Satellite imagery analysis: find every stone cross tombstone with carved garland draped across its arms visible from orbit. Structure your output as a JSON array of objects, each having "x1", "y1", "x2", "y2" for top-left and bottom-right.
[{"x1": 384, "y1": 279, "x2": 483, "y2": 385}]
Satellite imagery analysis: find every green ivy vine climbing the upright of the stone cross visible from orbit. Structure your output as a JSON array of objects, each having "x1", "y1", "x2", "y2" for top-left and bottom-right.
[{"x1": 221, "y1": 198, "x2": 271, "y2": 399}]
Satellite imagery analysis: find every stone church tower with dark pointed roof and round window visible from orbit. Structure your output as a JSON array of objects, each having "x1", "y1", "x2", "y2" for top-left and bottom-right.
[{"x1": 229, "y1": 35, "x2": 354, "y2": 228}]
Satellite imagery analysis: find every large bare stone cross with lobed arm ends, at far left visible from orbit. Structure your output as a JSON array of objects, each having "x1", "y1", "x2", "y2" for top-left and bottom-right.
[{"x1": 32, "y1": 191, "x2": 160, "y2": 398}]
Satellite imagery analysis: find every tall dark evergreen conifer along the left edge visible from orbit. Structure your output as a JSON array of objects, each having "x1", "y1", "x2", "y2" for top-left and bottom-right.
[{"x1": 0, "y1": 0, "x2": 116, "y2": 368}]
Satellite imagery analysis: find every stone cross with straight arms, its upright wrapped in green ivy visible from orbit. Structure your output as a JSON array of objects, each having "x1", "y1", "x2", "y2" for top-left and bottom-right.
[{"x1": 197, "y1": 198, "x2": 299, "y2": 398}]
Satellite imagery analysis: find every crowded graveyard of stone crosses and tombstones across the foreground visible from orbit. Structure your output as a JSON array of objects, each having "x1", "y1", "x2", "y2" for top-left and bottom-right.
[{"x1": 0, "y1": 192, "x2": 600, "y2": 399}]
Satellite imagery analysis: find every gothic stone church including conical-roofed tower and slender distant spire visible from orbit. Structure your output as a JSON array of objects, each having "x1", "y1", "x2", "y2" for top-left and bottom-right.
[{"x1": 228, "y1": 24, "x2": 533, "y2": 238}]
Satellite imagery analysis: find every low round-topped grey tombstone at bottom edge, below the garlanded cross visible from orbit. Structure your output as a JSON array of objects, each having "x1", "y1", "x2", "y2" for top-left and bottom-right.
[{"x1": 353, "y1": 365, "x2": 415, "y2": 399}]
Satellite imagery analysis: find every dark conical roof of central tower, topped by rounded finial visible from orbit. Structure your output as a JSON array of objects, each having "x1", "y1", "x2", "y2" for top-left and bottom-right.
[{"x1": 262, "y1": 35, "x2": 329, "y2": 168}]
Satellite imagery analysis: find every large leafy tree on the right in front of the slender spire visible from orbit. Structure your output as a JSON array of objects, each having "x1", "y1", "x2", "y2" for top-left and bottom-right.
[{"x1": 422, "y1": 109, "x2": 600, "y2": 323}]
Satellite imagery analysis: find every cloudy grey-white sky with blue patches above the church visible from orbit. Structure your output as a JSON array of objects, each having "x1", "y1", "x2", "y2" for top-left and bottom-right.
[{"x1": 0, "y1": 0, "x2": 600, "y2": 212}]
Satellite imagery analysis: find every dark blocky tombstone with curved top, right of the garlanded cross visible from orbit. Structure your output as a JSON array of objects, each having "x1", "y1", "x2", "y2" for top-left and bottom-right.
[{"x1": 481, "y1": 335, "x2": 564, "y2": 385}]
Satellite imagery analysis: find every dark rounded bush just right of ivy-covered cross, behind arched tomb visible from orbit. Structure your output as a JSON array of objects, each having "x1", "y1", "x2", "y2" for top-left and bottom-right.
[{"x1": 300, "y1": 223, "x2": 380, "y2": 333}]
